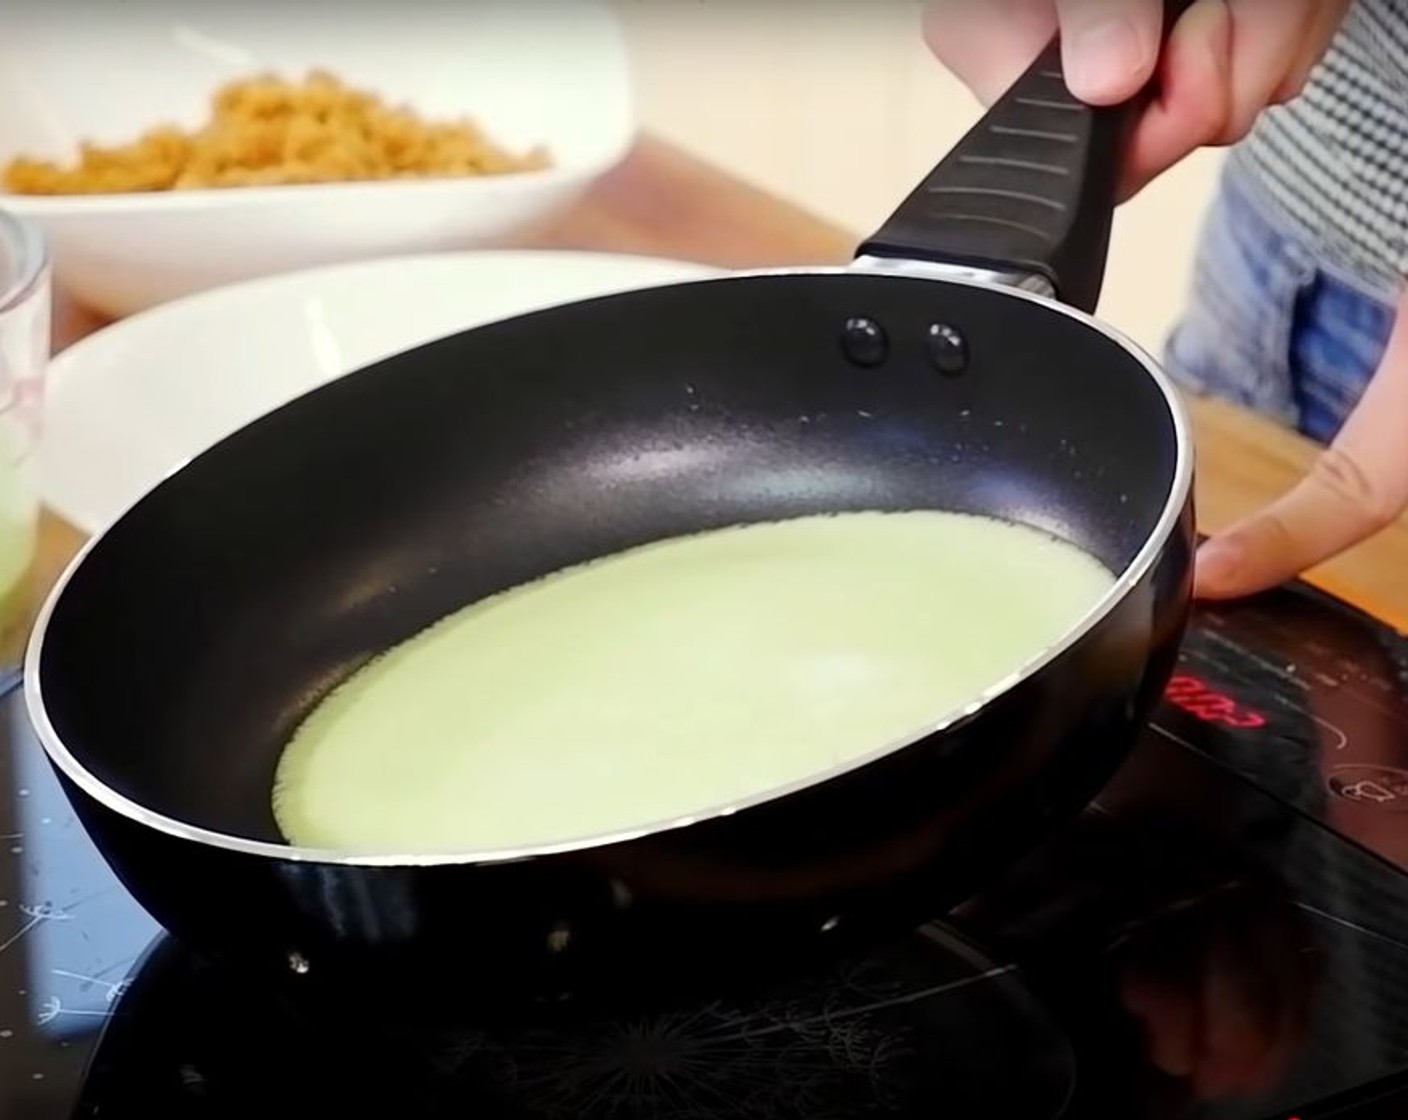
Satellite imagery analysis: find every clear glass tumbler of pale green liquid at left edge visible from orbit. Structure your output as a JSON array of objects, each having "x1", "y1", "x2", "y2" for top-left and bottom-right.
[{"x1": 0, "y1": 211, "x2": 51, "y2": 656}]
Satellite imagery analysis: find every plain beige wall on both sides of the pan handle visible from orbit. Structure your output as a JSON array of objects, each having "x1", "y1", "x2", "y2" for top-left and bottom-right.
[{"x1": 617, "y1": 0, "x2": 1221, "y2": 352}]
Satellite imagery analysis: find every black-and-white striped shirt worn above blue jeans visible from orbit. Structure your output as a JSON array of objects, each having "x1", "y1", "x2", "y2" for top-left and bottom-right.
[{"x1": 1229, "y1": 0, "x2": 1408, "y2": 300}]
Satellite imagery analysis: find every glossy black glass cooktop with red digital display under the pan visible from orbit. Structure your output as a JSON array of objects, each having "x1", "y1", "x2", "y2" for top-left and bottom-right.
[{"x1": 8, "y1": 589, "x2": 1408, "y2": 1120}]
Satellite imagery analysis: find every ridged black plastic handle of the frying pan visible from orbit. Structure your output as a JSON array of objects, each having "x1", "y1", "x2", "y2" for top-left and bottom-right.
[{"x1": 856, "y1": 0, "x2": 1193, "y2": 313}]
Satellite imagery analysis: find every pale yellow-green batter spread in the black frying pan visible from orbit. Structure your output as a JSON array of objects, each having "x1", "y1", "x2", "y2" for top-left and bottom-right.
[{"x1": 273, "y1": 511, "x2": 1114, "y2": 854}]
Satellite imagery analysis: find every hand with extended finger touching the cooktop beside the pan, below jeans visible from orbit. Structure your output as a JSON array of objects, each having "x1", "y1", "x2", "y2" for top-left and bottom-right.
[{"x1": 1194, "y1": 296, "x2": 1408, "y2": 599}]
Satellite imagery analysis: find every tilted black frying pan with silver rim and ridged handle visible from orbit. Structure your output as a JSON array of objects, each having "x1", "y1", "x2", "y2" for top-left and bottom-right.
[{"x1": 25, "y1": 17, "x2": 1194, "y2": 1007}]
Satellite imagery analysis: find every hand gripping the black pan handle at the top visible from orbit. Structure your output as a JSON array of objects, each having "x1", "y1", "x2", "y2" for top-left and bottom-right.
[{"x1": 924, "y1": 0, "x2": 1350, "y2": 199}]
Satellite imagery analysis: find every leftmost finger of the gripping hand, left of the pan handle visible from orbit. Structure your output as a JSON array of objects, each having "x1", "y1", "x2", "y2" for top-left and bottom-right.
[{"x1": 924, "y1": 0, "x2": 1056, "y2": 106}]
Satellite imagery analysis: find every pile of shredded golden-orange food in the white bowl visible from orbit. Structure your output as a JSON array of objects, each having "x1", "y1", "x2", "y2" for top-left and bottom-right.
[{"x1": 3, "y1": 70, "x2": 552, "y2": 194}]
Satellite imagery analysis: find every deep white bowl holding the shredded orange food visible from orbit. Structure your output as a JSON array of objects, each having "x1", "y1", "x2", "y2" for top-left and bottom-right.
[{"x1": 0, "y1": 0, "x2": 635, "y2": 317}]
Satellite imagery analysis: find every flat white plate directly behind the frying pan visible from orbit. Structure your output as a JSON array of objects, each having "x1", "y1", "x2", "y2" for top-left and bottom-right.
[{"x1": 39, "y1": 252, "x2": 718, "y2": 533}]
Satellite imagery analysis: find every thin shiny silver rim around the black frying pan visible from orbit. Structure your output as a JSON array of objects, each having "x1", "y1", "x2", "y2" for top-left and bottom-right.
[{"x1": 24, "y1": 265, "x2": 1195, "y2": 868}]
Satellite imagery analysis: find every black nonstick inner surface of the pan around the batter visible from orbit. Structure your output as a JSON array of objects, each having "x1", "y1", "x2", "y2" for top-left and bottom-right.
[{"x1": 39, "y1": 272, "x2": 1181, "y2": 842}]
